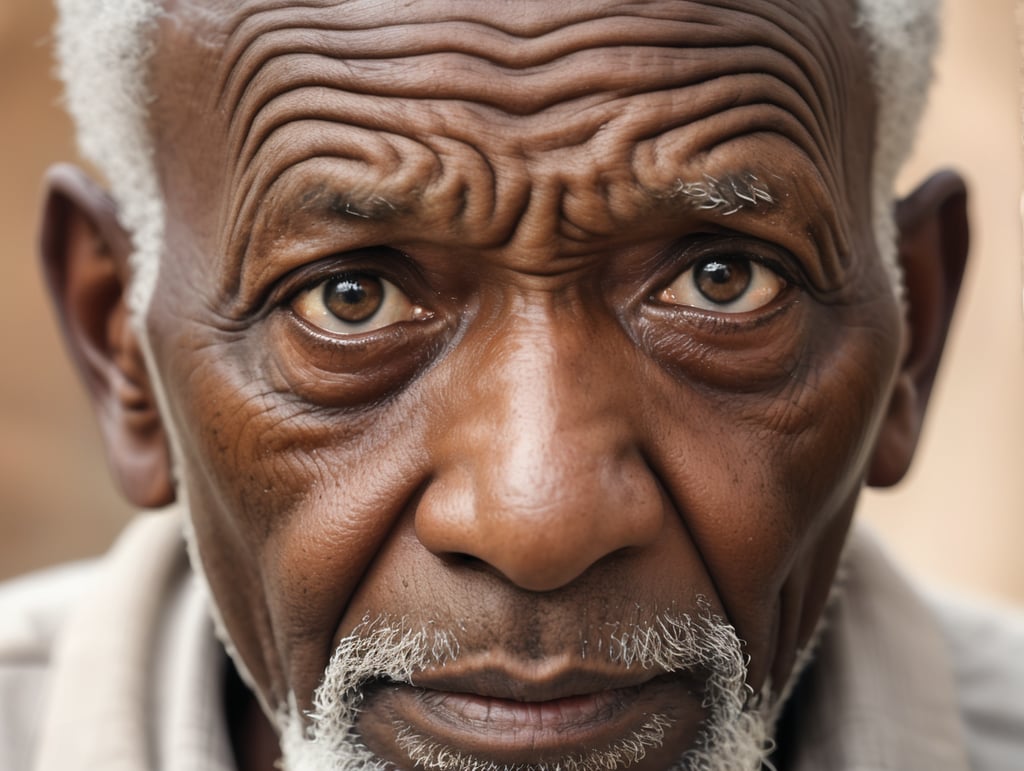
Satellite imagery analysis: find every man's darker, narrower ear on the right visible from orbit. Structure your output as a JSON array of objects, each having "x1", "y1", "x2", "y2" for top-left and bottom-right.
[{"x1": 867, "y1": 171, "x2": 969, "y2": 487}]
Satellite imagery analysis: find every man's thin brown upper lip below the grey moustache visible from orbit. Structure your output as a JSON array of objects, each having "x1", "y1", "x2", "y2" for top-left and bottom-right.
[{"x1": 403, "y1": 658, "x2": 667, "y2": 702}]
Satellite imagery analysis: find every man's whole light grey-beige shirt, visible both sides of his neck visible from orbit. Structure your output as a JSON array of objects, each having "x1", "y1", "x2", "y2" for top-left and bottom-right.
[{"x1": 0, "y1": 511, "x2": 1024, "y2": 771}]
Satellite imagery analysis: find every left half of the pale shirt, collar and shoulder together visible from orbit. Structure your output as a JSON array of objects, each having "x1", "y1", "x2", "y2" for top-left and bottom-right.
[{"x1": 0, "y1": 512, "x2": 234, "y2": 771}]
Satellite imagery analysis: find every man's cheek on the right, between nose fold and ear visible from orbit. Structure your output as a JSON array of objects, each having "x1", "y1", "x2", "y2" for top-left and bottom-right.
[{"x1": 651, "y1": 301, "x2": 896, "y2": 675}]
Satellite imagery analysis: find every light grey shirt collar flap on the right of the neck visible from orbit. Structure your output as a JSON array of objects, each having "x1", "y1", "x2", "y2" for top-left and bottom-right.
[{"x1": 786, "y1": 528, "x2": 970, "y2": 771}]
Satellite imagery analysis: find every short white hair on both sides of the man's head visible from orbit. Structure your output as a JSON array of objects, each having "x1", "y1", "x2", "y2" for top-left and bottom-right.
[{"x1": 56, "y1": 0, "x2": 940, "y2": 324}]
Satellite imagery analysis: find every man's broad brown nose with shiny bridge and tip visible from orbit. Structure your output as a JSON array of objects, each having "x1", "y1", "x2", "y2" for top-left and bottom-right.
[{"x1": 416, "y1": 301, "x2": 667, "y2": 592}]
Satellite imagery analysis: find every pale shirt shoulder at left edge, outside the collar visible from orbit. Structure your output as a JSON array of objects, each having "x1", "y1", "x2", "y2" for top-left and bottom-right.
[{"x1": 0, "y1": 562, "x2": 96, "y2": 768}]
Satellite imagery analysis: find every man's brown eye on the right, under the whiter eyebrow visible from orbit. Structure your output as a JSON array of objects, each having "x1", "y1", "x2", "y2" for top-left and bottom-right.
[{"x1": 655, "y1": 257, "x2": 786, "y2": 313}]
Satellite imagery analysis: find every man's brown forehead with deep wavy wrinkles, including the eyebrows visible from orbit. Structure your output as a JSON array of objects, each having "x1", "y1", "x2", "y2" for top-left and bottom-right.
[{"x1": 148, "y1": 0, "x2": 873, "y2": 311}]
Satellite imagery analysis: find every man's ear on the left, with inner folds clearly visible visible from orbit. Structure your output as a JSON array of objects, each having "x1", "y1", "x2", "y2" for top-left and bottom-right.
[{"x1": 40, "y1": 166, "x2": 174, "y2": 508}]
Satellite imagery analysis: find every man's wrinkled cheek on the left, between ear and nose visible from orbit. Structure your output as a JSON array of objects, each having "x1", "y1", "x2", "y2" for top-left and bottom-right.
[{"x1": 156, "y1": 325, "x2": 440, "y2": 702}]
